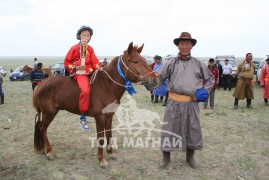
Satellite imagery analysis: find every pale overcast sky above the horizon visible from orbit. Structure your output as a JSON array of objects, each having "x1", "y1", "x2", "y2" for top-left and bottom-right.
[{"x1": 0, "y1": 0, "x2": 269, "y2": 57}]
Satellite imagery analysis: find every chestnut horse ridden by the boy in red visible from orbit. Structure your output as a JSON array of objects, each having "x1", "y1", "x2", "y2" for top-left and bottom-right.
[{"x1": 33, "y1": 43, "x2": 159, "y2": 168}]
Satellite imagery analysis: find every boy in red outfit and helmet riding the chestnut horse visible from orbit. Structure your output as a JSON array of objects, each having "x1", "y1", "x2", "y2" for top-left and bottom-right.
[{"x1": 64, "y1": 26, "x2": 100, "y2": 130}]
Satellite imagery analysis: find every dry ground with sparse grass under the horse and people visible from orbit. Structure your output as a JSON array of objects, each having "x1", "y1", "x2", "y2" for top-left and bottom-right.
[{"x1": 0, "y1": 59, "x2": 269, "y2": 180}]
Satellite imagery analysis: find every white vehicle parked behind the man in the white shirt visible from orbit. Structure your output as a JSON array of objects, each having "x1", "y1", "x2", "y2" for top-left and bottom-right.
[{"x1": 215, "y1": 55, "x2": 238, "y2": 86}]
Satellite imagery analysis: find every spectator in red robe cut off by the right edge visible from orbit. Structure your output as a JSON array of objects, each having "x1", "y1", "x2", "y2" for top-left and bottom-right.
[{"x1": 260, "y1": 57, "x2": 269, "y2": 106}]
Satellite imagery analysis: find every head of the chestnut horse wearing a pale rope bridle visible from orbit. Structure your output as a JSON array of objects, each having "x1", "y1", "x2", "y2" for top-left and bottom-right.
[{"x1": 120, "y1": 42, "x2": 159, "y2": 89}]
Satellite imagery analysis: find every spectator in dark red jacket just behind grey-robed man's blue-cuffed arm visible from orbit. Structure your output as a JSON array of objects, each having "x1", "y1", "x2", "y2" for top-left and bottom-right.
[{"x1": 203, "y1": 58, "x2": 219, "y2": 110}]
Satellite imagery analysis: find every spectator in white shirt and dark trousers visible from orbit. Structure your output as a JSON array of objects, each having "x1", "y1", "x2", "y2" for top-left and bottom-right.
[{"x1": 222, "y1": 59, "x2": 233, "y2": 91}]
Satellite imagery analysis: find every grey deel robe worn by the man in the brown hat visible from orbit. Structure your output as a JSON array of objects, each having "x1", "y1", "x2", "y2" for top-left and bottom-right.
[{"x1": 157, "y1": 57, "x2": 215, "y2": 151}]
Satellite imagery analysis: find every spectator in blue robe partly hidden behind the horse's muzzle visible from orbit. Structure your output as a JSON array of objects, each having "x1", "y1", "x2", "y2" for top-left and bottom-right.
[{"x1": 152, "y1": 55, "x2": 166, "y2": 103}]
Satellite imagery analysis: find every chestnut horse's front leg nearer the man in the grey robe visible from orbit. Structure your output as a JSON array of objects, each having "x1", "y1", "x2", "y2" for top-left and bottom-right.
[{"x1": 105, "y1": 114, "x2": 117, "y2": 160}]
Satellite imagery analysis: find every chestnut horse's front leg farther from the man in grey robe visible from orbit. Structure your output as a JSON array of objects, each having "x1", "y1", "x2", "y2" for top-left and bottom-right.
[{"x1": 95, "y1": 115, "x2": 108, "y2": 168}]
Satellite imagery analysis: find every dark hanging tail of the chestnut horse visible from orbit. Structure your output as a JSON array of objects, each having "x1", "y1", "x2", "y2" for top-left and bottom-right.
[{"x1": 34, "y1": 112, "x2": 44, "y2": 152}]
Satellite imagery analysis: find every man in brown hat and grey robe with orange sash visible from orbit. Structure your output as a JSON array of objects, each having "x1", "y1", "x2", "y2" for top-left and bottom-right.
[{"x1": 157, "y1": 32, "x2": 215, "y2": 168}]
